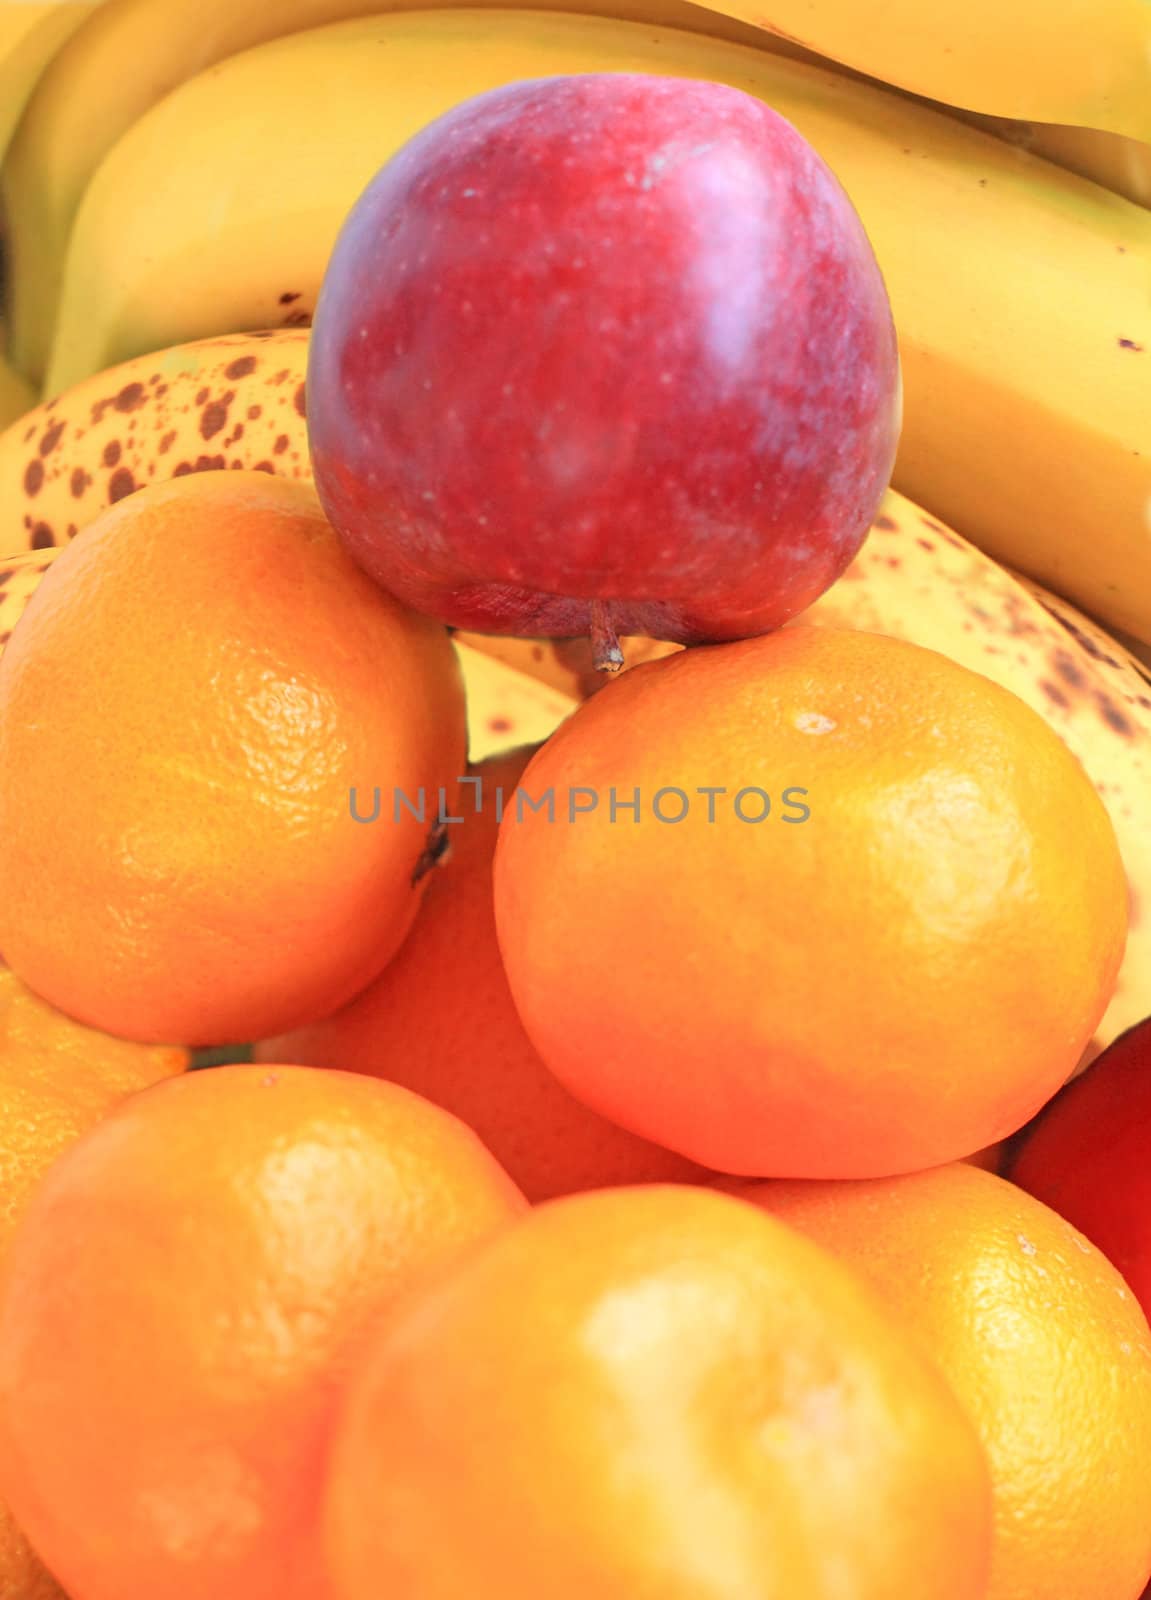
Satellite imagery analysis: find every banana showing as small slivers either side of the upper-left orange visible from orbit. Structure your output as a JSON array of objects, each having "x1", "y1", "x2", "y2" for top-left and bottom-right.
[{"x1": 0, "y1": 547, "x2": 578, "y2": 762}]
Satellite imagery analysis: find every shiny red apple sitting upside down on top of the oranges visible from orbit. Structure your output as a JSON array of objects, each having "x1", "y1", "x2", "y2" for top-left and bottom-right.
[{"x1": 307, "y1": 74, "x2": 901, "y2": 643}]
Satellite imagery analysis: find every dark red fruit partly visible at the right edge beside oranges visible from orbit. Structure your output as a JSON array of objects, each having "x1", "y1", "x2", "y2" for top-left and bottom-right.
[{"x1": 1012, "y1": 1018, "x2": 1151, "y2": 1317}]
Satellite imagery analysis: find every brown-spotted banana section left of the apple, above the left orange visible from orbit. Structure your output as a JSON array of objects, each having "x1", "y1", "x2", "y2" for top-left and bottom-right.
[{"x1": 0, "y1": 328, "x2": 311, "y2": 552}]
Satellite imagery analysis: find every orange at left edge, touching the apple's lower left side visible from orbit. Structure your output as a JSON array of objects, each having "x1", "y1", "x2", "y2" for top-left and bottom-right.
[{"x1": 0, "y1": 472, "x2": 466, "y2": 1045}]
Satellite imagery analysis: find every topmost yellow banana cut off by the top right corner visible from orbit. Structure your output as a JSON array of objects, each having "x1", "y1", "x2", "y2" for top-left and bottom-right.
[{"x1": 694, "y1": 0, "x2": 1151, "y2": 139}]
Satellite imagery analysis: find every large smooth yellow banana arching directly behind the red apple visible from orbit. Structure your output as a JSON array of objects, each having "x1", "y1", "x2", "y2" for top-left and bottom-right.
[{"x1": 50, "y1": 11, "x2": 1151, "y2": 640}]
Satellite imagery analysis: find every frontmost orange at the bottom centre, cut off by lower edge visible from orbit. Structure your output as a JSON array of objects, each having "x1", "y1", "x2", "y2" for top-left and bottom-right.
[{"x1": 327, "y1": 1186, "x2": 989, "y2": 1600}]
